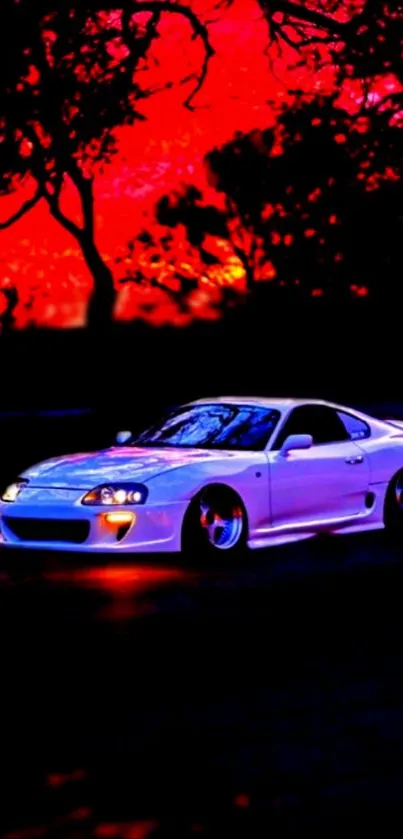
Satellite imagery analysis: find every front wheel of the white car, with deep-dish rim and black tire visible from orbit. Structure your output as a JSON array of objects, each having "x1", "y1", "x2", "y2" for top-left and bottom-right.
[{"x1": 182, "y1": 485, "x2": 247, "y2": 558}]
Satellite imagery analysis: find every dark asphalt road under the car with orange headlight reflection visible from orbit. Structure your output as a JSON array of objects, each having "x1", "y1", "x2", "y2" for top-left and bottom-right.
[{"x1": 0, "y1": 534, "x2": 403, "y2": 839}]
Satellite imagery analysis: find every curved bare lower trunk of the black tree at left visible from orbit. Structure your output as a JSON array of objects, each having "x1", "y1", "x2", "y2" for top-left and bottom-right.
[{"x1": 80, "y1": 233, "x2": 116, "y2": 331}]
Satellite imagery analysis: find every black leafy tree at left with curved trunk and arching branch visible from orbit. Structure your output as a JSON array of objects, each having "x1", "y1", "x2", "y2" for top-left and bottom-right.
[{"x1": 0, "y1": 0, "x2": 215, "y2": 327}]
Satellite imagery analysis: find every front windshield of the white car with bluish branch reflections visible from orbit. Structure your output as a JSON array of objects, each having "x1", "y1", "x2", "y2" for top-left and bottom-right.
[{"x1": 131, "y1": 403, "x2": 280, "y2": 451}]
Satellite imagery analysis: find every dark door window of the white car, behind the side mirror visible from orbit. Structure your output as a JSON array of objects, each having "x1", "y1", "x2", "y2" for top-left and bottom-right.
[{"x1": 273, "y1": 405, "x2": 350, "y2": 450}]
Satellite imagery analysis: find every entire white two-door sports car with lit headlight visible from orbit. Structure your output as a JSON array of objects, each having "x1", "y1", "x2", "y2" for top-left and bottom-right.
[{"x1": 0, "y1": 397, "x2": 403, "y2": 553}]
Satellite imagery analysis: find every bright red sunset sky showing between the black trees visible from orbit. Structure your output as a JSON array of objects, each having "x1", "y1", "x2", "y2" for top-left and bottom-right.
[{"x1": 0, "y1": 0, "x2": 392, "y2": 328}]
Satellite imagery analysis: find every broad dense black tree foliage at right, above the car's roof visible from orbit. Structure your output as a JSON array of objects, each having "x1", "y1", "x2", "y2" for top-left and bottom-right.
[{"x1": 157, "y1": 97, "x2": 403, "y2": 300}]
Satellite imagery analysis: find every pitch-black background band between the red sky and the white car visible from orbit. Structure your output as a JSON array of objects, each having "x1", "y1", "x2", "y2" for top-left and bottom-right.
[{"x1": 0, "y1": 298, "x2": 403, "y2": 415}]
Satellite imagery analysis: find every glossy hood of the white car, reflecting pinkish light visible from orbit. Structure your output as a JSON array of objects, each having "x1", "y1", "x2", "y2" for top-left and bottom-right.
[{"x1": 21, "y1": 446, "x2": 235, "y2": 489}]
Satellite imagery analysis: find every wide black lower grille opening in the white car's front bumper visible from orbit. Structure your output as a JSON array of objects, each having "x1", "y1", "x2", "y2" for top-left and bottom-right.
[{"x1": 3, "y1": 516, "x2": 90, "y2": 545}]
